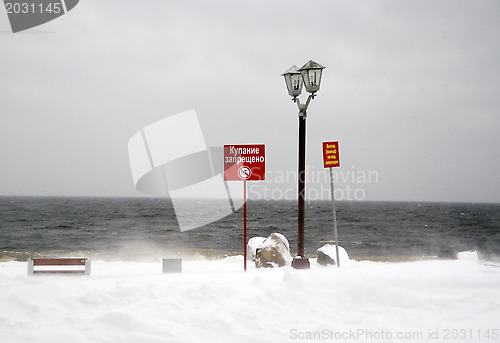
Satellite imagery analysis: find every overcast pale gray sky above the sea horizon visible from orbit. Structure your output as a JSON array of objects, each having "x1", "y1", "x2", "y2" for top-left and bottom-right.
[{"x1": 0, "y1": 0, "x2": 500, "y2": 202}]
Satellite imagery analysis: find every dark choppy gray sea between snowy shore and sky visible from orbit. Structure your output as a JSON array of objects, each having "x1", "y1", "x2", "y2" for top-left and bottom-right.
[{"x1": 0, "y1": 196, "x2": 500, "y2": 262}]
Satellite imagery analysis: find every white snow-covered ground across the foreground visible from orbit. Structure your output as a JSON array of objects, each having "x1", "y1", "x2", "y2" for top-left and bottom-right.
[{"x1": 0, "y1": 256, "x2": 500, "y2": 343}]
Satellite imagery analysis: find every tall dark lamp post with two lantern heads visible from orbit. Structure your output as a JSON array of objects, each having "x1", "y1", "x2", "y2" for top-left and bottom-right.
[{"x1": 282, "y1": 60, "x2": 325, "y2": 269}]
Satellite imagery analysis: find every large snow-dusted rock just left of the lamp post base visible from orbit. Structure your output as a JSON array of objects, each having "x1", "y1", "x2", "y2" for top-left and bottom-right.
[{"x1": 255, "y1": 233, "x2": 292, "y2": 268}]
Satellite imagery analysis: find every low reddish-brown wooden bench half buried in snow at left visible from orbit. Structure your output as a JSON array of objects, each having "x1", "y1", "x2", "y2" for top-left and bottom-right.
[{"x1": 28, "y1": 257, "x2": 90, "y2": 275}]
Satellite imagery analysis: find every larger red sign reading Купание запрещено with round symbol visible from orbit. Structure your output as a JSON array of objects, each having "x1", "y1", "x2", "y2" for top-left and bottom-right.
[{"x1": 224, "y1": 144, "x2": 266, "y2": 181}]
